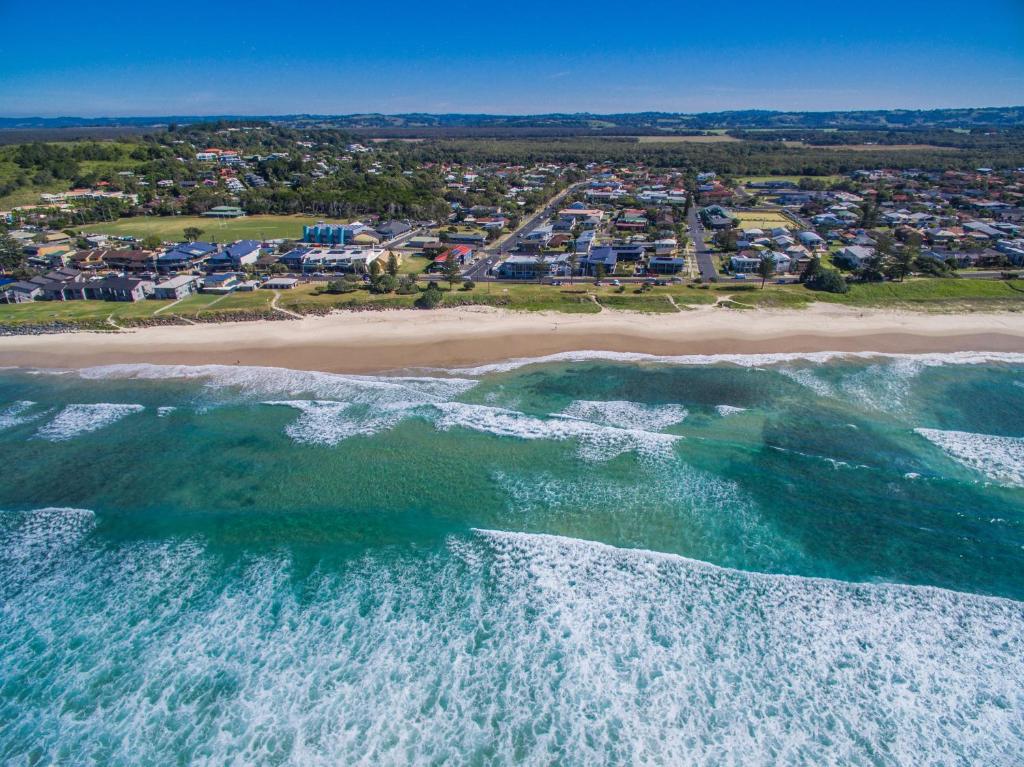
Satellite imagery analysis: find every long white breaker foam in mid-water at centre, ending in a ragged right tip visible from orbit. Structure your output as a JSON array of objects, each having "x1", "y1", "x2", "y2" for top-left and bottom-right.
[{"x1": 433, "y1": 402, "x2": 680, "y2": 461}]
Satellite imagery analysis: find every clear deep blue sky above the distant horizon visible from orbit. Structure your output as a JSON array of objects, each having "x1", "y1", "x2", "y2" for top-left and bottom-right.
[{"x1": 0, "y1": 0, "x2": 1024, "y2": 117}]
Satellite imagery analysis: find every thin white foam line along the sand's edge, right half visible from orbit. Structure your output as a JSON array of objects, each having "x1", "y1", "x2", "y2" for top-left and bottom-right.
[{"x1": 452, "y1": 350, "x2": 1024, "y2": 376}]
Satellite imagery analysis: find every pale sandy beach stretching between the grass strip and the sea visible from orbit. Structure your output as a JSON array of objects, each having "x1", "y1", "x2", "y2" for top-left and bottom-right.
[{"x1": 0, "y1": 305, "x2": 1024, "y2": 373}]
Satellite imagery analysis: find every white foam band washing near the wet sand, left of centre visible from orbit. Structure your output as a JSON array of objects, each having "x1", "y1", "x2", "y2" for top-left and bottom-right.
[{"x1": 78, "y1": 365, "x2": 477, "y2": 404}]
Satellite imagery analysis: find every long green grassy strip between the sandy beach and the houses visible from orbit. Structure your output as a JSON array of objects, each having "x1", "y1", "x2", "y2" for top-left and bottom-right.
[{"x1": 0, "y1": 279, "x2": 1024, "y2": 330}]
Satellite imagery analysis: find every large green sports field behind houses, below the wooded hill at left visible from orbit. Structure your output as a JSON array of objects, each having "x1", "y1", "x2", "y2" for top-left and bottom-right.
[{"x1": 82, "y1": 216, "x2": 345, "y2": 243}]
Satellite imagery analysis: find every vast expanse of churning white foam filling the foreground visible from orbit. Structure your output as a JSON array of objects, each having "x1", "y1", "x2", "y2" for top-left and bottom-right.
[{"x1": 0, "y1": 530, "x2": 1024, "y2": 767}]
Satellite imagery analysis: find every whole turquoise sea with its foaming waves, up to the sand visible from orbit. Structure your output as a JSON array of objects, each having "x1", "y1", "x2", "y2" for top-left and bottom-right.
[{"x1": 0, "y1": 354, "x2": 1024, "y2": 765}]
